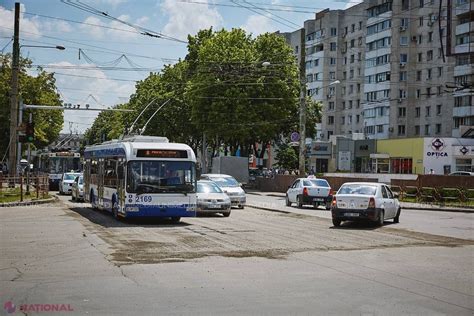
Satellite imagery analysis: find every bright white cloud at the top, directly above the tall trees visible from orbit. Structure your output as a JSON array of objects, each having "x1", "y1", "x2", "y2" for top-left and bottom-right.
[{"x1": 161, "y1": 0, "x2": 223, "y2": 39}]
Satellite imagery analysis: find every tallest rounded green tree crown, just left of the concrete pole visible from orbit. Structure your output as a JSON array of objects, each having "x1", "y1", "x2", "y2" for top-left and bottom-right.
[{"x1": 186, "y1": 29, "x2": 299, "y2": 157}]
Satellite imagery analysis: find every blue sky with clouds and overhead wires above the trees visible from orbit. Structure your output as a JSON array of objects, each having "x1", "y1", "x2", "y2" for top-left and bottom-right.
[{"x1": 0, "y1": 0, "x2": 356, "y2": 133}]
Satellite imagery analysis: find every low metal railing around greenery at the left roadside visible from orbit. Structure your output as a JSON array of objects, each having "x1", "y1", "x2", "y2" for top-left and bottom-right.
[{"x1": 0, "y1": 174, "x2": 49, "y2": 202}]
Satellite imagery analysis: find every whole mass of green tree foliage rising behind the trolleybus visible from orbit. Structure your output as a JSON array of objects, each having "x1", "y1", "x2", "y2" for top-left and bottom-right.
[{"x1": 86, "y1": 29, "x2": 319, "y2": 155}]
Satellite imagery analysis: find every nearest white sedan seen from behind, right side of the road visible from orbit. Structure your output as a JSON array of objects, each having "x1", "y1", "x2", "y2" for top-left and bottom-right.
[{"x1": 331, "y1": 182, "x2": 401, "y2": 227}]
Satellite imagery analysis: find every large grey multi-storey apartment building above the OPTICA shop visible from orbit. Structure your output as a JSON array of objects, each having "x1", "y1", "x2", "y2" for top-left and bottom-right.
[{"x1": 286, "y1": 0, "x2": 462, "y2": 140}]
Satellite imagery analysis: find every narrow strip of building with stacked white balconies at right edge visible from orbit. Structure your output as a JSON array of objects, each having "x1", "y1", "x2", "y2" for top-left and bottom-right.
[{"x1": 452, "y1": 0, "x2": 474, "y2": 138}]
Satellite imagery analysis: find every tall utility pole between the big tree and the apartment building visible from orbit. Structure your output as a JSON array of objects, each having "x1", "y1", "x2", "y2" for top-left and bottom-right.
[{"x1": 299, "y1": 27, "x2": 306, "y2": 177}]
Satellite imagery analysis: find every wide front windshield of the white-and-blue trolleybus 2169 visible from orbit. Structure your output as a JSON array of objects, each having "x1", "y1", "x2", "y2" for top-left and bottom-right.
[{"x1": 127, "y1": 160, "x2": 196, "y2": 194}]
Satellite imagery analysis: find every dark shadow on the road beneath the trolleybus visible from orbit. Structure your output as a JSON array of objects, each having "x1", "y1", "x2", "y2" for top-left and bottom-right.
[{"x1": 69, "y1": 207, "x2": 191, "y2": 228}]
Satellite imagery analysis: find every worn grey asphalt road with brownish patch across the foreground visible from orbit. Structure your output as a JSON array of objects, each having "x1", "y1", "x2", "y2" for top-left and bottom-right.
[{"x1": 0, "y1": 197, "x2": 474, "y2": 315}]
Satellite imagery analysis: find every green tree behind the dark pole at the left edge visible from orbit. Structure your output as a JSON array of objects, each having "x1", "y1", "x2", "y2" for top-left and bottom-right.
[{"x1": 0, "y1": 54, "x2": 64, "y2": 158}]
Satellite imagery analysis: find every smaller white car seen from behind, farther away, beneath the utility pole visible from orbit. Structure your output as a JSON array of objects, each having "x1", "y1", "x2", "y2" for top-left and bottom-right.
[{"x1": 286, "y1": 178, "x2": 333, "y2": 210}]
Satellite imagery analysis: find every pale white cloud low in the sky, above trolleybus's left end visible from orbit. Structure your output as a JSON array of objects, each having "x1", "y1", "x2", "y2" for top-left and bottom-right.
[{"x1": 49, "y1": 61, "x2": 135, "y2": 132}]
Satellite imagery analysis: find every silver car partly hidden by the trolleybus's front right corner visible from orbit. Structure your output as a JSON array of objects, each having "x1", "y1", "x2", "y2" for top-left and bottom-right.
[{"x1": 196, "y1": 180, "x2": 231, "y2": 217}]
